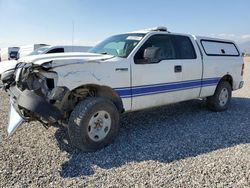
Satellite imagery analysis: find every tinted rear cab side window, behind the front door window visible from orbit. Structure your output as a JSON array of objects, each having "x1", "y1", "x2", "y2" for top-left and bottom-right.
[{"x1": 174, "y1": 35, "x2": 196, "y2": 59}]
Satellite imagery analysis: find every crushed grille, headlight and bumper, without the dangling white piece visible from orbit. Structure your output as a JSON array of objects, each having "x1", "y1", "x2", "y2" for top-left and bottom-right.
[{"x1": 10, "y1": 64, "x2": 66, "y2": 125}]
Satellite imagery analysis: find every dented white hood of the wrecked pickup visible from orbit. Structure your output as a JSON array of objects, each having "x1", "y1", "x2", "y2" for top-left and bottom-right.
[{"x1": 18, "y1": 52, "x2": 114, "y2": 65}]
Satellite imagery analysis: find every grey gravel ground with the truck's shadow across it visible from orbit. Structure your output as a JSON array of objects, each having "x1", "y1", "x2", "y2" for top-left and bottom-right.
[{"x1": 0, "y1": 63, "x2": 250, "y2": 187}]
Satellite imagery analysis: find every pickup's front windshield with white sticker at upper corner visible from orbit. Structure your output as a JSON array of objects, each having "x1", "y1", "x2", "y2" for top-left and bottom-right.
[{"x1": 89, "y1": 33, "x2": 145, "y2": 58}]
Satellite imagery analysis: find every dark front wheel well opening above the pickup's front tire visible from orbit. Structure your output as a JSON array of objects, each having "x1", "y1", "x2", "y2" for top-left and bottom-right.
[{"x1": 72, "y1": 84, "x2": 124, "y2": 113}]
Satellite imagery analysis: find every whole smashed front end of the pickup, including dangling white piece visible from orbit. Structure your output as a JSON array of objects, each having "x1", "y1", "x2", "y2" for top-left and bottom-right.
[{"x1": 1, "y1": 62, "x2": 70, "y2": 135}]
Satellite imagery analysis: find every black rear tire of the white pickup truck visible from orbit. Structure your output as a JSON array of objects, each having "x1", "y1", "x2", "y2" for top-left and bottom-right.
[{"x1": 207, "y1": 80, "x2": 232, "y2": 112}]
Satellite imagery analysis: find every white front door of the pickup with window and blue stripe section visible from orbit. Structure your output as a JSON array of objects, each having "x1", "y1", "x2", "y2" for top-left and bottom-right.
[{"x1": 131, "y1": 34, "x2": 182, "y2": 110}]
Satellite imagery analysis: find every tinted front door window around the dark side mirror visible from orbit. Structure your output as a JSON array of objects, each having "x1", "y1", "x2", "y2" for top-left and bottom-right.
[{"x1": 134, "y1": 35, "x2": 176, "y2": 64}]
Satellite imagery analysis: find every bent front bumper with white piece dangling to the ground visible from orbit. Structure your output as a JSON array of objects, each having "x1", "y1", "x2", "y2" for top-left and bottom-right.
[{"x1": 7, "y1": 86, "x2": 63, "y2": 135}]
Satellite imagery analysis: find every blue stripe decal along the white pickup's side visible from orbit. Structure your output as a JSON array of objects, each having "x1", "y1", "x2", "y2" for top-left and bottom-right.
[{"x1": 115, "y1": 78, "x2": 220, "y2": 98}]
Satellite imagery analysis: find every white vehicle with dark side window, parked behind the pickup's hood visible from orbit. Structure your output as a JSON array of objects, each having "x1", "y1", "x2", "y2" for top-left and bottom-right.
[{"x1": 29, "y1": 45, "x2": 91, "y2": 56}]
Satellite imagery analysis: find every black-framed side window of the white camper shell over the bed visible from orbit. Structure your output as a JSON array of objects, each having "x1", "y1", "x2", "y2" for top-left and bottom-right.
[{"x1": 201, "y1": 40, "x2": 240, "y2": 56}]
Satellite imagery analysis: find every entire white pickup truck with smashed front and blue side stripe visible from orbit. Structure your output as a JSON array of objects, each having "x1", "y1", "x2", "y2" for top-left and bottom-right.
[{"x1": 0, "y1": 27, "x2": 244, "y2": 151}]
